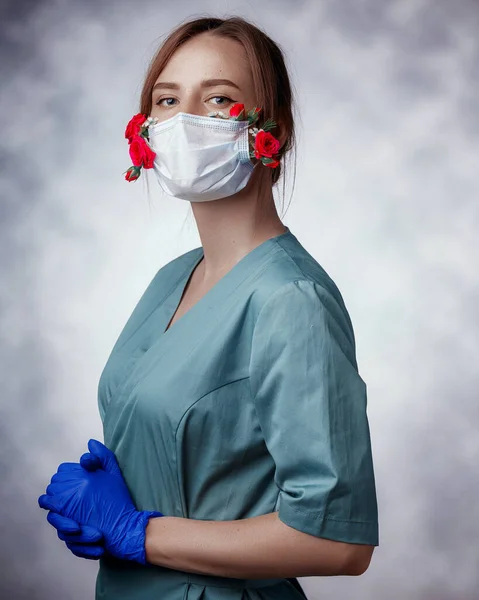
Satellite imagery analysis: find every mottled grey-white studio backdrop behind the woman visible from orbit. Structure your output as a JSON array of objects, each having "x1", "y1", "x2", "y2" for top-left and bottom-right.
[{"x1": 0, "y1": 0, "x2": 479, "y2": 600}]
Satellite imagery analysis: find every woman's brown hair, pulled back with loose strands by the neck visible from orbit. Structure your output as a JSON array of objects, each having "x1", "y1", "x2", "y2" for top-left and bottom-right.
[{"x1": 140, "y1": 16, "x2": 296, "y2": 217}]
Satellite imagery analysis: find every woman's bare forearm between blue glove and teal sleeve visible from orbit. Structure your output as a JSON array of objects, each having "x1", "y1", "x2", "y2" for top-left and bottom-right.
[{"x1": 145, "y1": 512, "x2": 374, "y2": 579}]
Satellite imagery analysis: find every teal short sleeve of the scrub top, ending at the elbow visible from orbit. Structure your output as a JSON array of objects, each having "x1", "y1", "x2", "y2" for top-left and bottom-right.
[{"x1": 249, "y1": 280, "x2": 379, "y2": 546}]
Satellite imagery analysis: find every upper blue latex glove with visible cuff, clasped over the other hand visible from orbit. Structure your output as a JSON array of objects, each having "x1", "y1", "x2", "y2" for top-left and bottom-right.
[{"x1": 38, "y1": 440, "x2": 163, "y2": 564}]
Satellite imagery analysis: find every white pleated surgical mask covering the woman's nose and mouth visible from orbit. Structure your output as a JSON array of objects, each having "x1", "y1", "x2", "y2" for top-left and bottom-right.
[{"x1": 148, "y1": 112, "x2": 254, "y2": 202}]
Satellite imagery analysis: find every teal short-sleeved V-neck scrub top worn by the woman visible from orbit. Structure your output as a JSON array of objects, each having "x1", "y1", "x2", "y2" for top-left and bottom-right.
[{"x1": 95, "y1": 228, "x2": 379, "y2": 600}]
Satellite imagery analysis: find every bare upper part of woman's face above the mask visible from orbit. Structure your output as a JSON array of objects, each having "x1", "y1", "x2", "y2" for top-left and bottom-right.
[{"x1": 150, "y1": 33, "x2": 255, "y2": 121}]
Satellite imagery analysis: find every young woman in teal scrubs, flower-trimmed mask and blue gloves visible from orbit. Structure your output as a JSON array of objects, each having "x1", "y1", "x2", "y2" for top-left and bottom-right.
[{"x1": 39, "y1": 17, "x2": 378, "y2": 600}]
